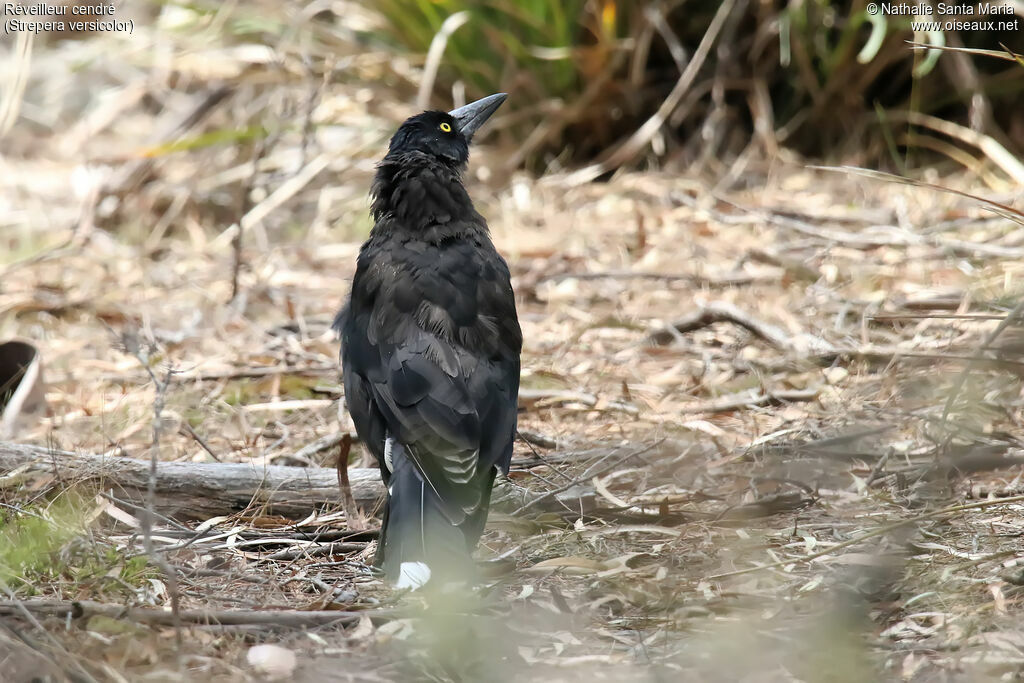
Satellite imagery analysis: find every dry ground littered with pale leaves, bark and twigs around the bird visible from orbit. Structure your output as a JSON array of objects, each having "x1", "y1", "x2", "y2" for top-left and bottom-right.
[{"x1": 0, "y1": 12, "x2": 1024, "y2": 682}]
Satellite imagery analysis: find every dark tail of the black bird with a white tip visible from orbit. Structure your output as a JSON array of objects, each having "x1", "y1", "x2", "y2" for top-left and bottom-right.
[{"x1": 374, "y1": 442, "x2": 475, "y2": 589}]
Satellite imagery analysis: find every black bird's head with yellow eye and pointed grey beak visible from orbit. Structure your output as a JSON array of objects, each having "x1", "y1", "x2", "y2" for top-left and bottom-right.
[{"x1": 388, "y1": 92, "x2": 508, "y2": 167}]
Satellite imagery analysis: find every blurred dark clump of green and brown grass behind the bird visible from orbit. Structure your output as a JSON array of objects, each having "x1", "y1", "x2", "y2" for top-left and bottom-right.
[{"x1": 354, "y1": 0, "x2": 1024, "y2": 176}]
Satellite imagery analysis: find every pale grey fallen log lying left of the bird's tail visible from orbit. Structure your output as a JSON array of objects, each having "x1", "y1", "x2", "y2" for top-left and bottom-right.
[{"x1": 0, "y1": 441, "x2": 384, "y2": 519}]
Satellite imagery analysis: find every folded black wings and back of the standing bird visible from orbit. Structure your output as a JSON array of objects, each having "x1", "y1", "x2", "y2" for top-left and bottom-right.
[{"x1": 342, "y1": 232, "x2": 521, "y2": 524}]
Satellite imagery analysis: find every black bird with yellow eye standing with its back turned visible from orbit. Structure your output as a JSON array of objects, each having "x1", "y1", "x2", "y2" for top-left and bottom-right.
[{"x1": 334, "y1": 93, "x2": 522, "y2": 588}]
